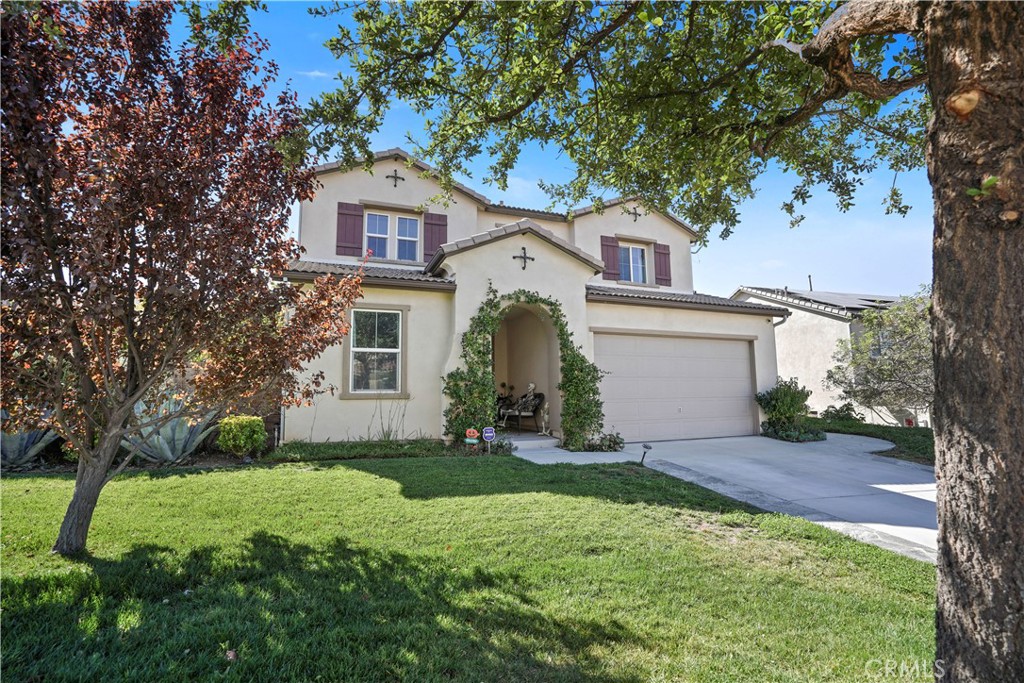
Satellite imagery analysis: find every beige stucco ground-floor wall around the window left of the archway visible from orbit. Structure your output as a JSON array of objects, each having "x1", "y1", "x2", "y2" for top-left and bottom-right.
[{"x1": 284, "y1": 287, "x2": 453, "y2": 442}]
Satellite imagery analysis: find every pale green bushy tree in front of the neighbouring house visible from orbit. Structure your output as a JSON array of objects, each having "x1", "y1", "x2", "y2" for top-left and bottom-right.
[{"x1": 825, "y1": 288, "x2": 935, "y2": 414}]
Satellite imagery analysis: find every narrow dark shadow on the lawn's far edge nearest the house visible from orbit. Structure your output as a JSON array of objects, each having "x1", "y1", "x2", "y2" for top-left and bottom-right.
[{"x1": 327, "y1": 457, "x2": 763, "y2": 514}]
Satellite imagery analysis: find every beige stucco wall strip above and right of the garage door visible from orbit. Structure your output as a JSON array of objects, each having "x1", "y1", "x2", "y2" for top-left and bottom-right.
[{"x1": 587, "y1": 302, "x2": 777, "y2": 391}]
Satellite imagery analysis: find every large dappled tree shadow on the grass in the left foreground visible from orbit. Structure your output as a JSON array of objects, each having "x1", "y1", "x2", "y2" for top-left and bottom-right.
[{"x1": 2, "y1": 532, "x2": 636, "y2": 681}]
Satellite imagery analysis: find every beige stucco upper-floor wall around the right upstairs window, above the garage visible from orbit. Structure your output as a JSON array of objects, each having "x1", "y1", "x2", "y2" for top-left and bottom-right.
[{"x1": 573, "y1": 202, "x2": 693, "y2": 292}]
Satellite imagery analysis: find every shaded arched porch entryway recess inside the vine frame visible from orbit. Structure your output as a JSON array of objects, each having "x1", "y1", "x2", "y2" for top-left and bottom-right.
[{"x1": 494, "y1": 303, "x2": 562, "y2": 432}]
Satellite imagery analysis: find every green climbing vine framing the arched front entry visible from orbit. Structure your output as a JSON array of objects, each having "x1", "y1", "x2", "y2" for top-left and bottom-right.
[{"x1": 443, "y1": 284, "x2": 604, "y2": 451}]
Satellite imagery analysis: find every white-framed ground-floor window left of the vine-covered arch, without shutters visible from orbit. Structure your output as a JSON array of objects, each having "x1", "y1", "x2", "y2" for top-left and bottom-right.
[{"x1": 349, "y1": 308, "x2": 401, "y2": 393}]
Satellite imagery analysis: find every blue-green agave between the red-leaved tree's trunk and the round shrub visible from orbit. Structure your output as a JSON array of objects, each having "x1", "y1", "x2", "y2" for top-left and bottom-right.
[{"x1": 121, "y1": 398, "x2": 216, "y2": 465}]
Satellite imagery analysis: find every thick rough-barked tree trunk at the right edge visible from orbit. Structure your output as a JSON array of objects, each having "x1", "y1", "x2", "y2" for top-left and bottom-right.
[{"x1": 925, "y1": 2, "x2": 1024, "y2": 682}]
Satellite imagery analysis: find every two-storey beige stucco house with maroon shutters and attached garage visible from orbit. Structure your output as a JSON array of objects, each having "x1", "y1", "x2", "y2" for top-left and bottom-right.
[{"x1": 283, "y1": 150, "x2": 785, "y2": 441}]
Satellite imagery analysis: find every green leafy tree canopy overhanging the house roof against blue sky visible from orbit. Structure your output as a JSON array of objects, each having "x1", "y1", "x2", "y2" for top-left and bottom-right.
[{"x1": 309, "y1": 2, "x2": 928, "y2": 234}]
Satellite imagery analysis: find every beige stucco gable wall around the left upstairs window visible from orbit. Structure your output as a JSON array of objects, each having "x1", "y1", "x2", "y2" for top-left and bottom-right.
[{"x1": 299, "y1": 161, "x2": 483, "y2": 262}]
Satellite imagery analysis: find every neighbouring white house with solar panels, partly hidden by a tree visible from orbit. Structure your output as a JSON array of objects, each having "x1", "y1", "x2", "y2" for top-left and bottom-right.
[{"x1": 731, "y1": 287, "x2": 928, "y2": 424}]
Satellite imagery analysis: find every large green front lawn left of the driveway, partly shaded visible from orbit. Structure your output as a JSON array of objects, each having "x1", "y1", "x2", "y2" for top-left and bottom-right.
[{"x1": 0, "y1": 457, "x2": 935, "y2": 683}]
